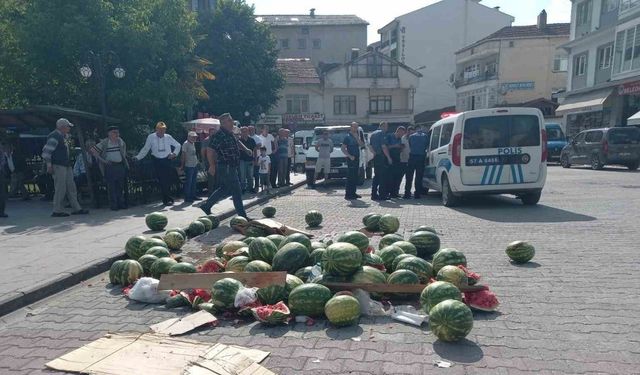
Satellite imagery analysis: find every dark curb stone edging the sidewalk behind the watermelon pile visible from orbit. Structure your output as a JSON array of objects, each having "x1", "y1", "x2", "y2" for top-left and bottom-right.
[{"x1": 0, "y1": 180, "x2": 306, "y2": 317}]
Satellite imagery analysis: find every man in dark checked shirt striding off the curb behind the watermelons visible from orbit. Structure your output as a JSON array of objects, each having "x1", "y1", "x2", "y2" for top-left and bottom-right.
[{"x1": 200, "y1": 113, "x2": 253, "y2": 218}]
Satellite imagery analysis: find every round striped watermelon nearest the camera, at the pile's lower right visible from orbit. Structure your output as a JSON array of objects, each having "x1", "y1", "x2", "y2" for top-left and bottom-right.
[{"x1": 429, "y1": 299, "x2": 473, "y2": 342}]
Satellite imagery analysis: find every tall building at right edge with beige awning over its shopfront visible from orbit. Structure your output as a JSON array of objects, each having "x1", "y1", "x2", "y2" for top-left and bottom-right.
[{"x1": 556, "y1": 0, "x2": 640, "y2": 135}]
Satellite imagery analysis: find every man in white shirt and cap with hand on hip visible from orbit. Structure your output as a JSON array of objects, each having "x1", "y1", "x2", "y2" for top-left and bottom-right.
[{"x1": 136, "y1": 121, "x2": 181, "y2": 206}]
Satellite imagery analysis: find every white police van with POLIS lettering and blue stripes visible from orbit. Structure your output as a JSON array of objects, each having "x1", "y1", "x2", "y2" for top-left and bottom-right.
[{"x1": 423, "y1": 107, "x2": 547, "y2": 207}]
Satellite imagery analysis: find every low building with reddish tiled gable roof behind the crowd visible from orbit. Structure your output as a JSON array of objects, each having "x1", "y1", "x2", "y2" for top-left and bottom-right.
[{"x1": 263, "y1": 51, "x2": 421, "y2": 130}]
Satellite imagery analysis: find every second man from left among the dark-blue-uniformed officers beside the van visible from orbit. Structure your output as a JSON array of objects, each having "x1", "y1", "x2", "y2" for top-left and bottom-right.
[{"x1": 369, "y1": 122, "x2": 392, "y2": 201}]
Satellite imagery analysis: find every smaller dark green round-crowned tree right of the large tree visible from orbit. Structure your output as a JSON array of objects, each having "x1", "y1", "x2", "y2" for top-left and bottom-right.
[{"x1": 196, "y1": 0, "x2": 284, "y2": 120}]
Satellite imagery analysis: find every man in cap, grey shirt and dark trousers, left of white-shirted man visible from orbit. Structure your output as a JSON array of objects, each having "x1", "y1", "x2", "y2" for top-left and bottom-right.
[{"x1": 94, "y1": 126, "x2": 129, "y2": 211}]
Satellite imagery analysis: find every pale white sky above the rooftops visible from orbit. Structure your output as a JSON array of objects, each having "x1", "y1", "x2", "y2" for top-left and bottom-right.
[{"x1": 247, "y1": 0, "x2": 571, "y2": 43}]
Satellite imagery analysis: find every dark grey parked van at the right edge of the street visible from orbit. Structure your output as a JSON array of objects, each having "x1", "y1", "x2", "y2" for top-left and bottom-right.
[{"x1": 560, "y1": 127, "x2": 640, "y2": 170}]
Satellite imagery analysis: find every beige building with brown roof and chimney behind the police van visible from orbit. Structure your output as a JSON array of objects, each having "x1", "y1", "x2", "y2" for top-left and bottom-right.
[{"x1": 455, "y1": 10, "x2": 570, "y2": 116}]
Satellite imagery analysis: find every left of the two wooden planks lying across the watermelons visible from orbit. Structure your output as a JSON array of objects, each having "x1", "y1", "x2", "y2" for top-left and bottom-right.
[{"x1": 158, "y1": 271, "x2": 287, "y2": 290}]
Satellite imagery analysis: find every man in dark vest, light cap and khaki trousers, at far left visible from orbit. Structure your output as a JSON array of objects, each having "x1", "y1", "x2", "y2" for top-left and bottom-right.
[{"x1": 42, "y1": 118, "x2": 89, "y2": 217}]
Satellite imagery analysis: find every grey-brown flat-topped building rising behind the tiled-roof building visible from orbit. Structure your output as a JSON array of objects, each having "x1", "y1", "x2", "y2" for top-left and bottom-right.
[{"x1": 256, "y1": 9, "x2": 369, "y2": 66}]
